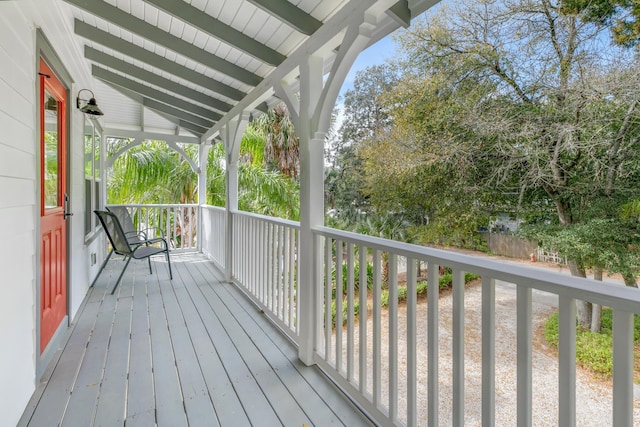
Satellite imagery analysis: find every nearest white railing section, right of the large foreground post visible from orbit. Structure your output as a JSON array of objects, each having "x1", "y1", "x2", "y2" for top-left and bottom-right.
[{"x1": 312, "y1": 227, "x2": 640, "y2": 426}]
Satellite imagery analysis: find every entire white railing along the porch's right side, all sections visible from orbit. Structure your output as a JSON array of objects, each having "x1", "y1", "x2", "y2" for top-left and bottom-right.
[{"x1": 146, "y1": 206, "x2": 640, "y2": 426}]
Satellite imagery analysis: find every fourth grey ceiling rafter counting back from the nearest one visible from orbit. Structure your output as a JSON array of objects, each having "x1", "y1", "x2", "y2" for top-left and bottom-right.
[{"x1": 74, "y1": 19, "x2": 247, "y2": 101}]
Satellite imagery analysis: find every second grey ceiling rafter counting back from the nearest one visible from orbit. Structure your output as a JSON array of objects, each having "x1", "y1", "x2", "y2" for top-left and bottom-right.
[{"x1": 144, "y1": 0, "x2": 288, "y2": 66}]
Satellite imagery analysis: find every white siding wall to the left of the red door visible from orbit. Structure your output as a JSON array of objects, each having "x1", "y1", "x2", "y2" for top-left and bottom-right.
[{"x1": 0, "y1": 2, "x2": 37, "y2": 426}]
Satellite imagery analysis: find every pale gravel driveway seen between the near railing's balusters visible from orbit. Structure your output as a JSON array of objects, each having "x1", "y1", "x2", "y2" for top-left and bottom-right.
[{"x1": 343, "y1": 272, "x2": 640, "y2": 427}]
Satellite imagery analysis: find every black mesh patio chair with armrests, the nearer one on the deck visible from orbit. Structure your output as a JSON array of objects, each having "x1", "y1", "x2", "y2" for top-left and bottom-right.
[{"x1": 93, "y1": 210, "x2": 173, "y2": 295}]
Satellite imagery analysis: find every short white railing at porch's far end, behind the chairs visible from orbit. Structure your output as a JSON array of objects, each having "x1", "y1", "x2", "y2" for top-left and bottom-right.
[{"x1": 109, "y1": 204, "x2": 199, "y2": 251}]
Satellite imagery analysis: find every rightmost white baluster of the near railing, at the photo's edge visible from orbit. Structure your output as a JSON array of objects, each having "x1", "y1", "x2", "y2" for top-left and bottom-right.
[{"x1": 613, "y1": 310, "x2": 634, "y2": 427}]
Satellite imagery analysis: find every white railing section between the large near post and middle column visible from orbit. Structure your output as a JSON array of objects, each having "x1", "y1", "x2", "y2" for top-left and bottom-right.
[{"x1": 231, "y1": 212, "x2": 300, "y2": 341}]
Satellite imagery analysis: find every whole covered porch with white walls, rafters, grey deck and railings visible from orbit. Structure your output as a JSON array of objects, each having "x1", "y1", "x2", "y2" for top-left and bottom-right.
[{"x1": 0, "y1": 0, "x2": 640, "y2": 427}]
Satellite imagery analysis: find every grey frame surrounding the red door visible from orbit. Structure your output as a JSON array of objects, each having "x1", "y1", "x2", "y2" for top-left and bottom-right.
[{"x1": 33, "y1": 29, "x2": 73, "y2": 385}]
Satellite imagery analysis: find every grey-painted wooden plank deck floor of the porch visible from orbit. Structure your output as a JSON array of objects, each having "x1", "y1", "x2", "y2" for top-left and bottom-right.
[{"x1": 19, "y1": 254, "x2": 369, "y2": 427}]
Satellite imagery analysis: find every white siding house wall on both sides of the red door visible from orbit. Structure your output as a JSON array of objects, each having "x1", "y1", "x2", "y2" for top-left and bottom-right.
[{"x1": 0, "y1": 0, "x2": 99, "y2": 427}]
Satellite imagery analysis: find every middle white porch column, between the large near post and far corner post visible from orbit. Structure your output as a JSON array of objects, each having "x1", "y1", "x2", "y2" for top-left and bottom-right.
[{"x1": 221, "y1": 112, "x2": 249, "y2": 282}]
